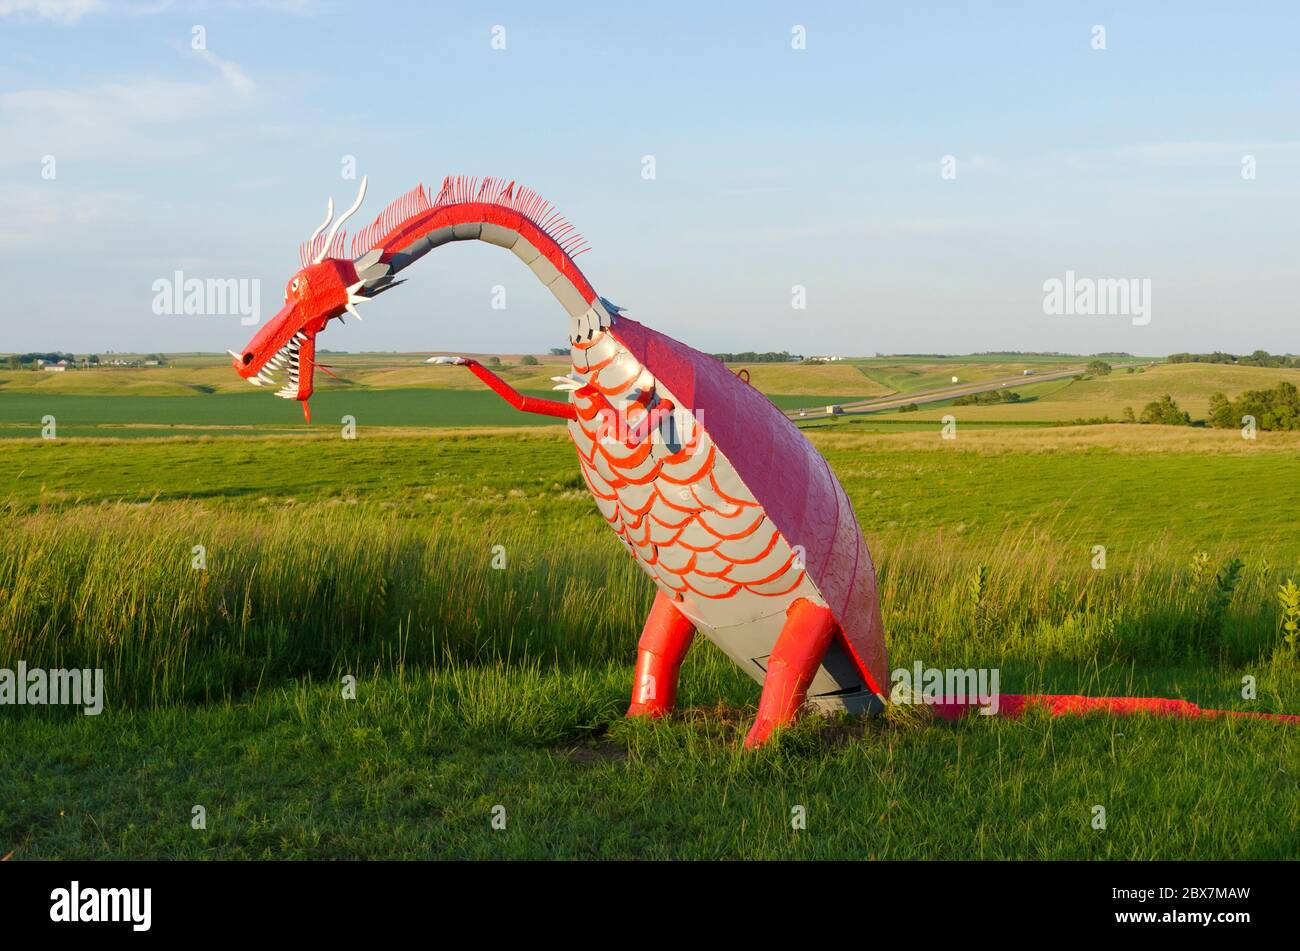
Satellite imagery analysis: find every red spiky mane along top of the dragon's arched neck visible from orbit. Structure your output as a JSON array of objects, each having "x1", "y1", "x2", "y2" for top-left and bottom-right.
[{"x1": 298, "y1": 175, "x2": 590, "y2": 266}]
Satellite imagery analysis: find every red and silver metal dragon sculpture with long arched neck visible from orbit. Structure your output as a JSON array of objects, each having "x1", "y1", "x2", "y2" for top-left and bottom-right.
[{"x1": 230, "y1": 177, "x2": 1289, "y2": 747}]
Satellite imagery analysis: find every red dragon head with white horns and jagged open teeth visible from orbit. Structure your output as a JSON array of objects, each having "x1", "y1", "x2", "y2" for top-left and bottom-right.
[{"x1": 229, "y1": 178, "x2": 400, "y2": 422}]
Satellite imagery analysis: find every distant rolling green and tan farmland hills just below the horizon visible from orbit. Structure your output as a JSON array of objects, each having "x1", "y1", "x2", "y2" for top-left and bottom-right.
[{"x1": 12, "y1": 353, "x2": 1300, "y2": 437}]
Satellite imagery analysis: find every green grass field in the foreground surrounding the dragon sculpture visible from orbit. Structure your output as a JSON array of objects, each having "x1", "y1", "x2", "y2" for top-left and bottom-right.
[{"x1": 0, "y1": 426, "x2": 1300, "y2": 859}]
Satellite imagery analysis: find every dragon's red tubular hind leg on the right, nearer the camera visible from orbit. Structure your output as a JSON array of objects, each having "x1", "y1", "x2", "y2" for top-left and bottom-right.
[{"x1": 745, "y1": 598, "x2": 835, "y2": 748}]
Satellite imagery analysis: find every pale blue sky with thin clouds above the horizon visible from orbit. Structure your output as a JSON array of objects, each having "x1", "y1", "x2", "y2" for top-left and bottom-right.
[{"x1": 0, "y1": 0, "x2": 1300, "y2": 355}]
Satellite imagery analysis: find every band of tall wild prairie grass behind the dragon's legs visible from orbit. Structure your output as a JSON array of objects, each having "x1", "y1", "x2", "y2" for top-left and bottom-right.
[{"x1": 0, "y1": 500, "x2": 1295, "y2": 707}]
